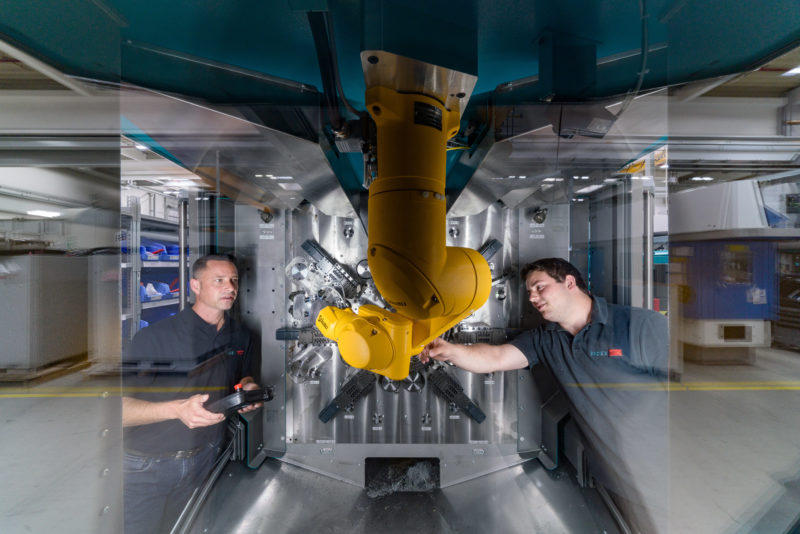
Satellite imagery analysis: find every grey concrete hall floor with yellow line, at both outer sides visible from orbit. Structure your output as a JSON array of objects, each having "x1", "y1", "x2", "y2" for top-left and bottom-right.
[{"x1": 0, "y1": 349, "x2": 800, "y2": 534}]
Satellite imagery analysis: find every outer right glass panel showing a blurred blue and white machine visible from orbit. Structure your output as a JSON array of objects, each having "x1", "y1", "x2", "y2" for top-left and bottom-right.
[{"x1": 669, "y1": 69, "x2": 800, "y2": 532}]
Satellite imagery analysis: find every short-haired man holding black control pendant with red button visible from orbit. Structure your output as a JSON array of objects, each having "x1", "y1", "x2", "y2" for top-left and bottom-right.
[{"x1": 122, "y1": 255, "x2": 258, "y2": 534}]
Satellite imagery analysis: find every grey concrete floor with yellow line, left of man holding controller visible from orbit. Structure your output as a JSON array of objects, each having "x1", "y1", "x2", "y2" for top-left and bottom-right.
[{"x1": 0, "y1": 373, "x2": 122, "y2": 534}]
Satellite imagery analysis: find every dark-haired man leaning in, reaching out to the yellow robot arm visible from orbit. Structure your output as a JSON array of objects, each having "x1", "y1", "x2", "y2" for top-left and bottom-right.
[{"x1": 420, "y1": 258, "x2": 669, "y2": 533}]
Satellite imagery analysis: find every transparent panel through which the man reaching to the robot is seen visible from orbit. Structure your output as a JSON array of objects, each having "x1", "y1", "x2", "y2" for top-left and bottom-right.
[{"x1": 500, "y1": 91, "x2": 670, "y2": 532}]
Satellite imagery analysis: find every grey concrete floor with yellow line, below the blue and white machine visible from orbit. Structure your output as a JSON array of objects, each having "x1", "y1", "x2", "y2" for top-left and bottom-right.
[{"x1": 670, "y1": 349, "x2": 800, "y2": 533}]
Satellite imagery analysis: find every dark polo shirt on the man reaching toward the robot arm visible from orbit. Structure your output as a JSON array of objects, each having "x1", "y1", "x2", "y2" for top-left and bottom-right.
[{"x1": 511, "y1": 296, "x2": 669, "y2": 510}]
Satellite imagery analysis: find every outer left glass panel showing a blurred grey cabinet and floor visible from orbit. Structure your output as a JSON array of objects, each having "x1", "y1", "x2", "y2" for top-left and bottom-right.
[{"x1": 0, "y1": 39, "x2": 122, "y2": 532}]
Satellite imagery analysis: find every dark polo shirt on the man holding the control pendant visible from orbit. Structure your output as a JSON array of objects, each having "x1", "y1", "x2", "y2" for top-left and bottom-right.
[{"x1": 123, "y1": 308, "x2": 255, "y2": 454}]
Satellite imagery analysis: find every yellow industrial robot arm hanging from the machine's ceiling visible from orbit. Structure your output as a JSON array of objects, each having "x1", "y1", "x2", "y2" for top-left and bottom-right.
[{"x1": 317, "y1": 87, "x2": 491, "y2": 380}]
